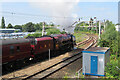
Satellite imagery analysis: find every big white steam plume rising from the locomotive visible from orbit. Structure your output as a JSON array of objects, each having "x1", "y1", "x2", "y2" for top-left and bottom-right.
[{"x1": 30, "y1": 0, "x2": 79, "y2": 33}]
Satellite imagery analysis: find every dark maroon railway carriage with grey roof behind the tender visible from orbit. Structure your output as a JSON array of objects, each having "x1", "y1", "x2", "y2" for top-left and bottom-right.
[{"x1": 1, "y1": 38, "x2": 31, "y2": 68}]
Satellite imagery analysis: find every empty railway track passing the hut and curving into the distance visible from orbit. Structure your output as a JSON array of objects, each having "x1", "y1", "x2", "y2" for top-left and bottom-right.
[{"x1": 1, "y1": 35, "x2": 96, "y2": 80}]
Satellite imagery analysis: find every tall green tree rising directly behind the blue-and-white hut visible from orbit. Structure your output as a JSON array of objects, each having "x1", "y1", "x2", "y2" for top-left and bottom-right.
[{"x1": 99, "y1": 21, "x2": 119, "y2": 56}]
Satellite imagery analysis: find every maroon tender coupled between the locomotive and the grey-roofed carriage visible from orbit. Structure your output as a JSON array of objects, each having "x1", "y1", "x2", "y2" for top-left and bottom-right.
[{"x1": 31, "y1": 37, "x2": 54, "y2": 58}]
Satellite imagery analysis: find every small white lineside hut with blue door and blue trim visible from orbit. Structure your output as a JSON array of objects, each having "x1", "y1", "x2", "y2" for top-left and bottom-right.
[{"x1": 82, "y1": 47, "x2": 110, "y2": 76}]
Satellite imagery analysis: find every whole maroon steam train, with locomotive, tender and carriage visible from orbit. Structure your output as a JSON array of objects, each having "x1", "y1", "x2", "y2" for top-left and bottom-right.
[{"x1": 0, "y1": 34, "x2": 75, "y2": 70}]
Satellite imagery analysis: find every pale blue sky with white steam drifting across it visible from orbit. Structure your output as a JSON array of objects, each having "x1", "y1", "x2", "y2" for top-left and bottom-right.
[{"x1": 0, "y1": 0, "x2": 118, "y2": 26}]
